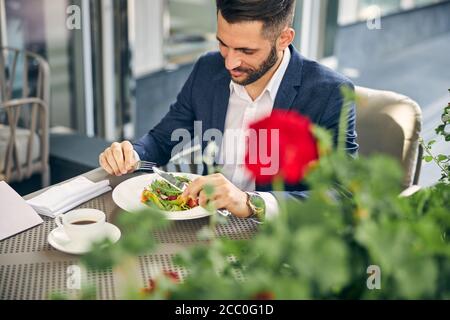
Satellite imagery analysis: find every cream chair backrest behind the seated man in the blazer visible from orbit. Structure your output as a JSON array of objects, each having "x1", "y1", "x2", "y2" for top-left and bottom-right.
[{"x1": 356, "y1": 87, "x2": 422, "y2": 188}]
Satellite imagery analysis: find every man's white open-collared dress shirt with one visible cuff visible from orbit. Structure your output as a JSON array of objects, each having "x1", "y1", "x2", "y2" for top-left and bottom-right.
[{"x1": 219, "y1": 48, "x2": 291, "y2": 219}]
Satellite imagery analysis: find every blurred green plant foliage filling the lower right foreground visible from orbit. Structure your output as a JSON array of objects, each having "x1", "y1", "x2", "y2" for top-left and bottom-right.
[{"x1": 55, "y1": 88, "x2": 450, "y2": 299}]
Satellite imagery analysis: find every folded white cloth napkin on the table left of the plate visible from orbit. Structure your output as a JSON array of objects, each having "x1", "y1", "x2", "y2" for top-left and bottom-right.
[{"x1": 27, "y1": 177, "x2": 111, "y2": 218}]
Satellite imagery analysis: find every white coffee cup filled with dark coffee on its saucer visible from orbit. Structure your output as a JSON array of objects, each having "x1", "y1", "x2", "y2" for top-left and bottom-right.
[{"x1": 55, "y1": 209, "x2": 106, "y2": 248}]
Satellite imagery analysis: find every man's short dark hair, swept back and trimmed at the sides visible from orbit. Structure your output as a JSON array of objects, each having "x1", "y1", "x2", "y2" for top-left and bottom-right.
[{"x1": 216, "y1": 0, "x2": 295, "y2": 39}]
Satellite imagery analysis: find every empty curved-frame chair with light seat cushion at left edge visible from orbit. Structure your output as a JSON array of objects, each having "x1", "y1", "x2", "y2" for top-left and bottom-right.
[{"x1": 0, "y1": 47, "x2": 50, "y2": 187}]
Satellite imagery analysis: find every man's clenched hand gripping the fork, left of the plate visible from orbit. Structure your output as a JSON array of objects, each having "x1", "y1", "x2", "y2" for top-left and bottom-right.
[{"x1": 99, "y1": 141, "x2": 136, "y2": 176}]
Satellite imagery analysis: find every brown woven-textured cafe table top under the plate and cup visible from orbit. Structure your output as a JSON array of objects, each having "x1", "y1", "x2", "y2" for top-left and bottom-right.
[{"x1": 0, "y1": 168, "x2": 256, "y2": 300}]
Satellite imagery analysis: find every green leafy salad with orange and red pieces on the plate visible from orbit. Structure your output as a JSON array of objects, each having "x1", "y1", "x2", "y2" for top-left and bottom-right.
[{"x1": 141, "y1": 176, "x2": 198, "y2": 211}]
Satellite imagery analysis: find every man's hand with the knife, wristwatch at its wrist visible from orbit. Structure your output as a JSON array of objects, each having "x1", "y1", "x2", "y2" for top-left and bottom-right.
[{"x1": 183, "y1": 173, "x2": 251, "y2": 218}]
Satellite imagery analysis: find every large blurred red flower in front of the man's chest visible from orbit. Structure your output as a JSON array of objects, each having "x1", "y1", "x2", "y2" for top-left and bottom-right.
[{"x1": 245, "y1": 110, "x2": 319, "y2": 184}]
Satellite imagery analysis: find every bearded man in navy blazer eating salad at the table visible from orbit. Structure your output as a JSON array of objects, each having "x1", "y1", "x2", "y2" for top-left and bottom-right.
[{"x1": 99, "y1": 0, "x2": 358, "y2": 221}]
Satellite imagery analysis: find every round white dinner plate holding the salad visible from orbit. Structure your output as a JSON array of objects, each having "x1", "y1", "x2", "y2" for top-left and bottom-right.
[{"x1": 112, "y1": 172, "x2": 211, "y2": 220}]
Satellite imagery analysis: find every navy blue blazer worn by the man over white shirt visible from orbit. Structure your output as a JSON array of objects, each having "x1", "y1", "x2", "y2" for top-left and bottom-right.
[{"x1": 133, "y1": 46, "x2": 358, "y2": 201}]
